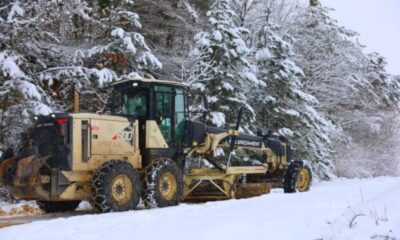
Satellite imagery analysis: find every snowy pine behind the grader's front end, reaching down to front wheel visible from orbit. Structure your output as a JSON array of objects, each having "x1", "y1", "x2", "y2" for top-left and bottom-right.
[{"x1": 253, "y1": 12, "x2": 333, "y2": 179}]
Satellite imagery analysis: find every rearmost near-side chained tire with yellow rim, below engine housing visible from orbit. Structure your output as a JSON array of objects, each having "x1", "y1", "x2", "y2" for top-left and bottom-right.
[{"x1": 91, "y1": 160, "x2": 141, "y2": 212}]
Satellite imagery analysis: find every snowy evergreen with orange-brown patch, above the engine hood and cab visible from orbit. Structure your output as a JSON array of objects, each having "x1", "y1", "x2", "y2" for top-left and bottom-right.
[{"x1": 36, "y1": 0, "x2": 162, "y2": 110}]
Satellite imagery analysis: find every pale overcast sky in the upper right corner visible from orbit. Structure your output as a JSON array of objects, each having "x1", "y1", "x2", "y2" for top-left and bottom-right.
[{"x1": 320, "y1": 0, "x2": 400, "y2": 75}]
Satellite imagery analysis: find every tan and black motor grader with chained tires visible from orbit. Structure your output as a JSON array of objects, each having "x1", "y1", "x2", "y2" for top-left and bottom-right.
[{"x1": 0, "y1": 78, "x2": 311, "y2": 213}]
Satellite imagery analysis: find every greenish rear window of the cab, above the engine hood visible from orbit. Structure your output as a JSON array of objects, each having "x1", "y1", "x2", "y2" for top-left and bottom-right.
[{"x1": 122, "y1": 91, "x2": 147, "y2": 118}]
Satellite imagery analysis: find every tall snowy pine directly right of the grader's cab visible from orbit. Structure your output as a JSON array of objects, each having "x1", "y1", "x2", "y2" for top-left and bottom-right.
[{"x1": 188, "y1": 0, "x2": 259, "y2": 130}]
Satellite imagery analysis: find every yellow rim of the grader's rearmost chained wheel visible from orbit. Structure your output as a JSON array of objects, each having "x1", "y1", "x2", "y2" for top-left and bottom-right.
[{"x1": 111, "y1": 174, "x2": 133, "y2": 205}]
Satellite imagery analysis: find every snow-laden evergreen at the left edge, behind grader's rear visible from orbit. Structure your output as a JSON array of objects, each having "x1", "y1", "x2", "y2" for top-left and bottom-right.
[{"x1": 0, "y1": 1, "x2": 51, "y2": 147}]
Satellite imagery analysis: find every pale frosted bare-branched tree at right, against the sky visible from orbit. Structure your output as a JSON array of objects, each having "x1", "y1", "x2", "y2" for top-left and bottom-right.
[{"x1": 290, "y1": 4, "x2": 399, "y2": 176}]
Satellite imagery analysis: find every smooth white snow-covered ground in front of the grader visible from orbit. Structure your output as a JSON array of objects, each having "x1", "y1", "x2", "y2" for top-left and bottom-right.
[{"x1": 0, "y1": 177, "x2": 400, "y2": 240}]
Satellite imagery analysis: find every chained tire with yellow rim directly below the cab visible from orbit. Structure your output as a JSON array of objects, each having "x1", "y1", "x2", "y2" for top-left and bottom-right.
[{"x1": 143, "y1": 158, "x2": 183, "y2": 208}]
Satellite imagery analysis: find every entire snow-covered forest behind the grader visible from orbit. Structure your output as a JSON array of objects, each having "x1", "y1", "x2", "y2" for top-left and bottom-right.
[{"x1": 0, "y1": 0, "x2": 400, "y2": 180}]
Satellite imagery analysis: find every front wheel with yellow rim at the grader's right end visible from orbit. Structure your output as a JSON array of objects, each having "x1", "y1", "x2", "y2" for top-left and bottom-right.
[{"x1": 283, "y1": 160, "x2": 312, "y2": 193}]
